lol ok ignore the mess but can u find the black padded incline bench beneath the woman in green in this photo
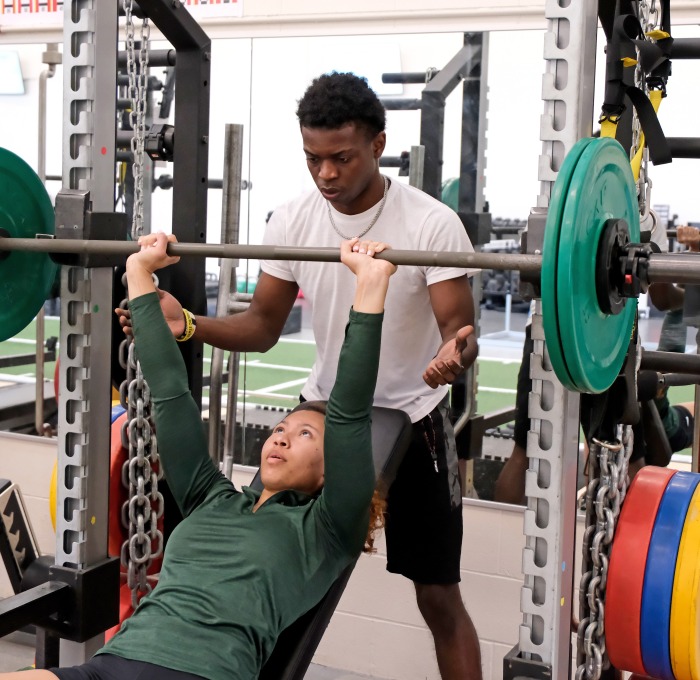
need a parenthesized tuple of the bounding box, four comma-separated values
(250, 406, 412, 680)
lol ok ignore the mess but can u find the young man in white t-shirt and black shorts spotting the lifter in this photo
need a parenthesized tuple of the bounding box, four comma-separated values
(124, 73, 482, 680)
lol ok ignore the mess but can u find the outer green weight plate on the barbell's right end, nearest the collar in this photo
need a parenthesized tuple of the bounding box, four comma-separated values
(557, 138, 639, 394)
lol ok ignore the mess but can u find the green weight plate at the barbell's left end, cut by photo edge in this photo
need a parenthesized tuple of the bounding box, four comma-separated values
(0, 148, 56, 341)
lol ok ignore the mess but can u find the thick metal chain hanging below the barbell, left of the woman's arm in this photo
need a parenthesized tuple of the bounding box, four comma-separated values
(119, 278, 163, 607)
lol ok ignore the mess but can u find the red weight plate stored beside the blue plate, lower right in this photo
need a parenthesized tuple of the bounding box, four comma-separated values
(605, 465, 676, 675)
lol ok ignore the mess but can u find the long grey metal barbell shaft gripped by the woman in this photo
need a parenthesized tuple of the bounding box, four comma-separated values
(0, 238, 542, 273)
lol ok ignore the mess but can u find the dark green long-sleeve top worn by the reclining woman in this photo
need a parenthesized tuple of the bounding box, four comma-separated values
(101, 293, 382, 680)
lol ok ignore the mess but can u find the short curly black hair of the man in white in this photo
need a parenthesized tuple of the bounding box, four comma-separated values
(297, 71, 386, 137)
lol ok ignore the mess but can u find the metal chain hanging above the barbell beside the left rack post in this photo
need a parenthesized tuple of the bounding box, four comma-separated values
(122, 0, 151, 241)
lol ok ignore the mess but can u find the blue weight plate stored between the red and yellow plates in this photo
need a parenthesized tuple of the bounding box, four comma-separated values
(640, 472, 700, 680)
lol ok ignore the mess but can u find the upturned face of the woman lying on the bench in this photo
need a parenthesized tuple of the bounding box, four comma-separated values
(260, 411, 325, 495)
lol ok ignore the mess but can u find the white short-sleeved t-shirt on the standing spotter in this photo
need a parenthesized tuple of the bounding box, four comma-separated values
(261, 181, 474, 422)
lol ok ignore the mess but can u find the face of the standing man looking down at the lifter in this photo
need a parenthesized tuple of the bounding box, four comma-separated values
(301, 123, 386, 215)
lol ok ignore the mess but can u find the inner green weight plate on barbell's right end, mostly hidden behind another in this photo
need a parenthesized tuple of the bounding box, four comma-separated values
(541, 137, 592, 389)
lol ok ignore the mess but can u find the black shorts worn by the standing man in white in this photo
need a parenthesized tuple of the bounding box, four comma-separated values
(386, 400, 462, 585)
